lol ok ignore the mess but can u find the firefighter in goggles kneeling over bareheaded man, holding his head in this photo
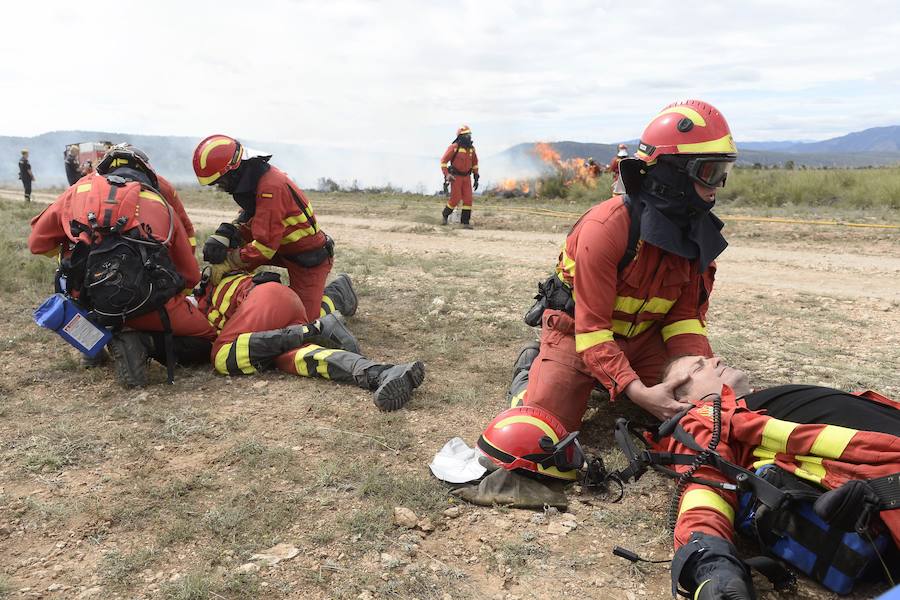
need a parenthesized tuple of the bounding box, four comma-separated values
(516, 100, 737, 431)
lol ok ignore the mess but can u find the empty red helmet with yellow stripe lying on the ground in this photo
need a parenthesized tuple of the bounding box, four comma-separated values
(478, 406, 584, 481)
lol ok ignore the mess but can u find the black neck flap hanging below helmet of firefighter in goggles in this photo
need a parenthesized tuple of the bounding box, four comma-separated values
(640, 158, 728, 273)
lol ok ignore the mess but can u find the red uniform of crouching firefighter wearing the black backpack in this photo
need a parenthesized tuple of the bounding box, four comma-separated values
(28, 174, 215, 339)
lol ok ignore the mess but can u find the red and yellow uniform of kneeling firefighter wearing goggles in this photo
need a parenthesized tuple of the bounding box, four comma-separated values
(512, 196, 715, 431)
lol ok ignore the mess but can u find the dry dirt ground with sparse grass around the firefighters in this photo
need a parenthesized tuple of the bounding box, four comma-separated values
(0, 192, 900, 600)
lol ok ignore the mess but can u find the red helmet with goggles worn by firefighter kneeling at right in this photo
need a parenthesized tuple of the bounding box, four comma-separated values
(635, 100, 737, 187)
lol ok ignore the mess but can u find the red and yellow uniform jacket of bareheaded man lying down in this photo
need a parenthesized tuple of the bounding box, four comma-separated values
(658, 386, 900, 549)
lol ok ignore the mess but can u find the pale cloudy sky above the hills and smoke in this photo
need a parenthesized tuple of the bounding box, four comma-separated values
(0, 0, 900, 155)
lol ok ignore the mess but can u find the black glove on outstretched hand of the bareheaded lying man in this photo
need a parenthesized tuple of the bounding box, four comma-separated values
(672, 533, 756, 600)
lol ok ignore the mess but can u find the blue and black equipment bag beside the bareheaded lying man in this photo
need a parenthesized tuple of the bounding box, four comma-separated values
(735, 465, 893, 595)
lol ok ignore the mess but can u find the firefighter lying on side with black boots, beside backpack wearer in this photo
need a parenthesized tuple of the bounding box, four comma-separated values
(197, 271, 425, 411)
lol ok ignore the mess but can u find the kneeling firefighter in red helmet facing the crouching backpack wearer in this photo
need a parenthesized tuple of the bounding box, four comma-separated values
(193, 135, 334, 315)
